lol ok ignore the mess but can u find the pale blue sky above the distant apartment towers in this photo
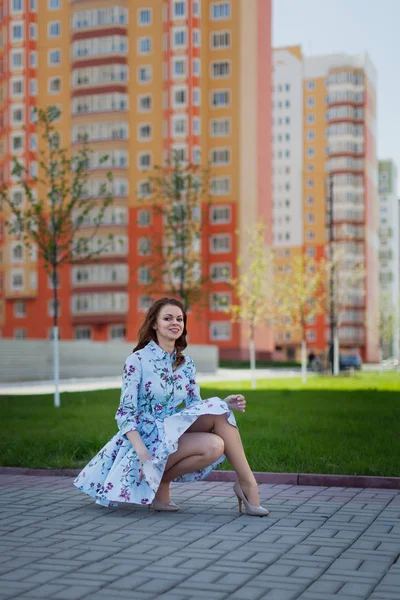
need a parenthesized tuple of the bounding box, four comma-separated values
(272, 0, 400, 188)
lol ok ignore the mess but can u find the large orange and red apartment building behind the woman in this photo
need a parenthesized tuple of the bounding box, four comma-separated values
(0, 0, 272, 355)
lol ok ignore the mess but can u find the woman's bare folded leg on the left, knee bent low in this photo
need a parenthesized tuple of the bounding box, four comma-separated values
(156, 431, 224, 502)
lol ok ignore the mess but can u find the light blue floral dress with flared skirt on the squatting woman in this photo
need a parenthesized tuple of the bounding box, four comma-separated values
(74, 341, 236, 506)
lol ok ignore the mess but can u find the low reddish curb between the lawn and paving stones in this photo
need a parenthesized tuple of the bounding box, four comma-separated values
(0, 467, 400, 490)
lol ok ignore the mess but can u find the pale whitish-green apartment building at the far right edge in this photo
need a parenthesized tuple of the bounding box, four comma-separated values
(379, 160, 400, 358)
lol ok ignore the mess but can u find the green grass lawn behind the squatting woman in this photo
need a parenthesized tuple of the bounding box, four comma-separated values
(0, 373, 400, 476)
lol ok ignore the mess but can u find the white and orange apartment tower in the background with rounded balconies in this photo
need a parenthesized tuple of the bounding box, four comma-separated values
(272, 46, 379, 361)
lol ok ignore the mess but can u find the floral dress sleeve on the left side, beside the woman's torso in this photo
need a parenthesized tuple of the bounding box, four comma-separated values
(115, 354, 142, 435)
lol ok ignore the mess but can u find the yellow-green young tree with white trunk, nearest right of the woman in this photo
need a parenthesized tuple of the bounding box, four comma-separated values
(226, 219, 274, 390)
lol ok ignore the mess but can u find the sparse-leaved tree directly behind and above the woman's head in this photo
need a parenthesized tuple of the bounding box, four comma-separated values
(141, 151, 209, 310)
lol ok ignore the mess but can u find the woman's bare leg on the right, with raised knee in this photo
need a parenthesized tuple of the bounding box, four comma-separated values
(188, 414, 260, 506)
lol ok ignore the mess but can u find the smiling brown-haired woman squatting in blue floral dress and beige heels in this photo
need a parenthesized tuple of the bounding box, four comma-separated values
(74, 298, 269, 516)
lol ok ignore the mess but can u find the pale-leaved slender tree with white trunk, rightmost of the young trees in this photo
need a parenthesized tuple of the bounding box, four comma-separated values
(326, 243, 365, 375)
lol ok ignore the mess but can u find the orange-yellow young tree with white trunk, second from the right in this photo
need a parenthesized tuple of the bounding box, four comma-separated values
(276, 253, 325, 383)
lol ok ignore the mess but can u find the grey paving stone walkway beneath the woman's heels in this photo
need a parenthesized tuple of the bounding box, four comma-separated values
(0, 475, 400, 600)
